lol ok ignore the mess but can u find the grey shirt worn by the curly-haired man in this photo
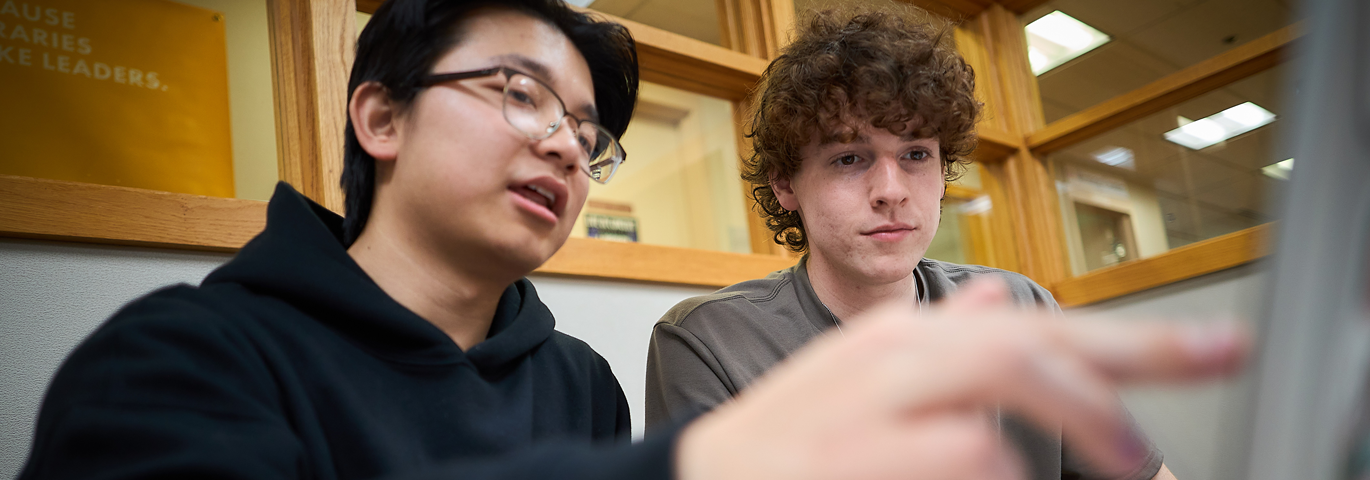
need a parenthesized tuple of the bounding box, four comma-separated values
(647, 256, 1162, 479)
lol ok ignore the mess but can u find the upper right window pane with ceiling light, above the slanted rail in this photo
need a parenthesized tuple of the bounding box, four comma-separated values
(1019, 0, 1296, 123)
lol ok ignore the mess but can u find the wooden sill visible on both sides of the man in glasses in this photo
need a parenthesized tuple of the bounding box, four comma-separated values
(0, 176, 796, 287)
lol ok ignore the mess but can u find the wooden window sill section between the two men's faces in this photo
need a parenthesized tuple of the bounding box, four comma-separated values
(536, 239, 796, 288)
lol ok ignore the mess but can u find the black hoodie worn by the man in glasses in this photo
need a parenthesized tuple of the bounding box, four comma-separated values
(19, 184, 673, 479)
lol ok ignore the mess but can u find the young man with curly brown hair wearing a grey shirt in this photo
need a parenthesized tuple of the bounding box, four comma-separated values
(647, 7, 1170, 479)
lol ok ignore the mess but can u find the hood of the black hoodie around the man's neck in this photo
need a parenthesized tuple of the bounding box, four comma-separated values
(203, 182, 555, 372)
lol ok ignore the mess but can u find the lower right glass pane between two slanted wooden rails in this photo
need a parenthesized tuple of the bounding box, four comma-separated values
(1049, 67, 1296, 274)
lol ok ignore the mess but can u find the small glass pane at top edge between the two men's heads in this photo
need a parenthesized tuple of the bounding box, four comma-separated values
(583, 0, 722, 45)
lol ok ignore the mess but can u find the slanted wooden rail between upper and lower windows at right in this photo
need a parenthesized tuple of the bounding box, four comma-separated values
(1028, 23, 1302, 155)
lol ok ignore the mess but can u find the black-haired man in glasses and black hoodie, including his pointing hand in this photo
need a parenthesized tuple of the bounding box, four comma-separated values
(21, 0, 1244, 480)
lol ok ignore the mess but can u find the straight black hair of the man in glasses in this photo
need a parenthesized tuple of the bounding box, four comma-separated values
(343, 0, 638, 245)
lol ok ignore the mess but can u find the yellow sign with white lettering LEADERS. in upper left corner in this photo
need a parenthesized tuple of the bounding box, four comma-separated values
(0, 0, 233, 197)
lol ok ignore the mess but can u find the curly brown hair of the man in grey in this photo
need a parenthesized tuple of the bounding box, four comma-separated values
(743, 5, 981, 254)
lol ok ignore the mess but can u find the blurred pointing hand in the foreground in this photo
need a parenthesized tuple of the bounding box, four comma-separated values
(675, 278, 1249, 480)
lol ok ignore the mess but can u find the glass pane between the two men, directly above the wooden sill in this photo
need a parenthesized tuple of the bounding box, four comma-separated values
(571, 82, 751, 254)
